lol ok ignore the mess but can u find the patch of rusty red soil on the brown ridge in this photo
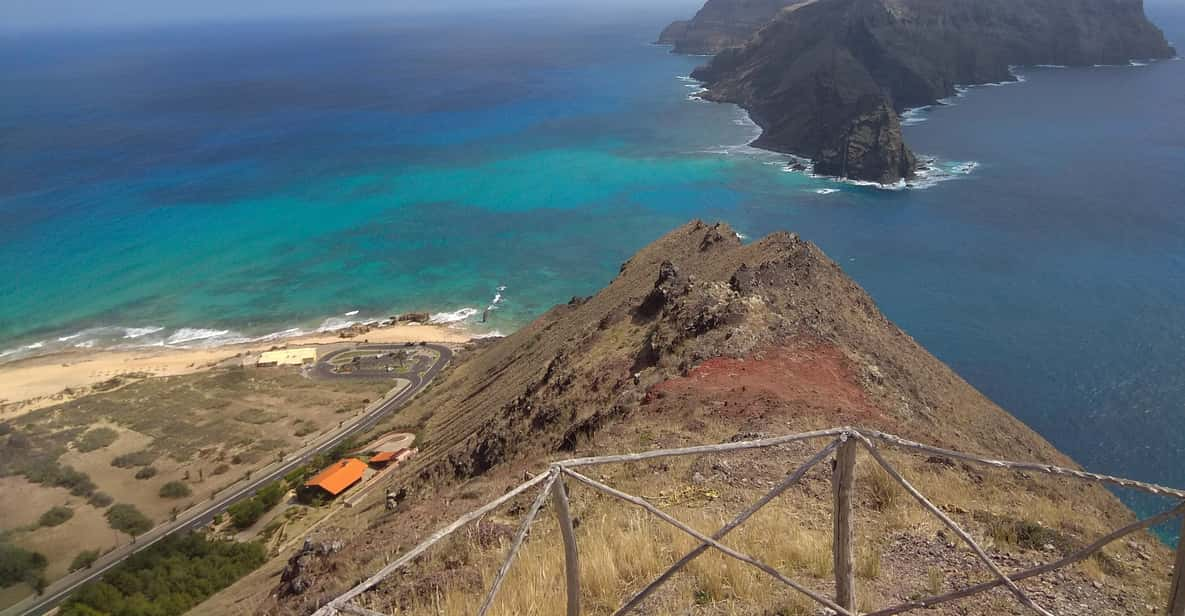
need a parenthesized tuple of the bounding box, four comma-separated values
(647, 342, 882, 423)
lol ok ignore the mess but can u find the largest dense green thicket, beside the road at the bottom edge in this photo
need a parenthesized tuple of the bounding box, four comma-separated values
(60, 533, 267, 616)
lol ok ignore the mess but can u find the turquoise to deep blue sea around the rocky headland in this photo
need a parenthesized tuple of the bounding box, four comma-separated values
(0, 1, 1185, 525)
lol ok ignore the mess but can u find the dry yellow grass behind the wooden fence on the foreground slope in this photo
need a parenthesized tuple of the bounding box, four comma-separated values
(317, 435, 1175, 616)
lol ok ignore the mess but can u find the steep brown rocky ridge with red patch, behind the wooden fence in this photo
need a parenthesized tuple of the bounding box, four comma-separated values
(223, 222, 1170, 615)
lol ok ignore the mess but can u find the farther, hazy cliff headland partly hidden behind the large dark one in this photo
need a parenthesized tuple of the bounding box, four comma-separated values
(658, 0, 803, 54)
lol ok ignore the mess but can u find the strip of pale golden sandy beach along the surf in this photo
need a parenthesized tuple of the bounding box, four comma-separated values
(0, 323, 472, 419)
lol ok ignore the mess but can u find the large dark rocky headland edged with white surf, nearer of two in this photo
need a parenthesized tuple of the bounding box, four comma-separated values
(693, 0, 1174, 184)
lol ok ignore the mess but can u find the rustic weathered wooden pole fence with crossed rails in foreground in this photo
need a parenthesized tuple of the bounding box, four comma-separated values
(314, 428, 1185, 616)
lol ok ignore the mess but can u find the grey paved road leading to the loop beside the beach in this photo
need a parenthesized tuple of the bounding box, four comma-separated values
(0, 345, 453, 616)
